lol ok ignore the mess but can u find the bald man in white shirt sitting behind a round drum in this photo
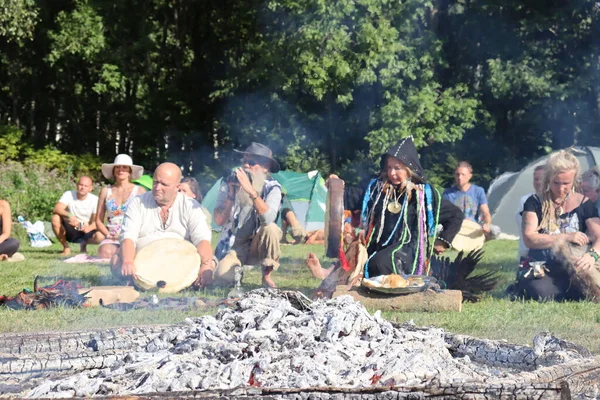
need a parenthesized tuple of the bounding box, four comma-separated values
(111, 163, 215, 286)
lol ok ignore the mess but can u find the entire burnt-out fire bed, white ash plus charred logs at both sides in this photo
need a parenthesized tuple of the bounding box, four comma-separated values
(0, 289, 600, 398)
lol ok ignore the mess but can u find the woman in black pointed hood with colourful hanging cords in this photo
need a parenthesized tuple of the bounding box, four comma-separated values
(307, 137, 463, 292)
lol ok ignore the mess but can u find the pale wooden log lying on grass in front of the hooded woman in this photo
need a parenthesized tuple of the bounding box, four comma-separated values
(333, 286, 462, 312)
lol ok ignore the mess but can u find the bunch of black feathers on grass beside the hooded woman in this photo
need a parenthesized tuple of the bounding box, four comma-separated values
(430, 249, 499, 302)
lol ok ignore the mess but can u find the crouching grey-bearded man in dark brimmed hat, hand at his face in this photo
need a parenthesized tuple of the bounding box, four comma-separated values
(213, 142, 281, 287)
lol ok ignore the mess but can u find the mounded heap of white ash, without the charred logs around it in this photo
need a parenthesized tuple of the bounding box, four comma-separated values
(18, 290, 576, 398)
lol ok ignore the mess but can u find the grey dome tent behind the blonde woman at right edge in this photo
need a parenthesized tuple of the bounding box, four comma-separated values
(487, 147, 600, 236)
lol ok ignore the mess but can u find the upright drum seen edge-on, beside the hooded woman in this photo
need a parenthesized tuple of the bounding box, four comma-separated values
(325, 179, 344, 258)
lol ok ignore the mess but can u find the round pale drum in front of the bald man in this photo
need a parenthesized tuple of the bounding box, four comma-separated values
(133, 238, 200, 293)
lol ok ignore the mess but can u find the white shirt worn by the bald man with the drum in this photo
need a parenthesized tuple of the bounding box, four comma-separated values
(120, 191, 211, 250)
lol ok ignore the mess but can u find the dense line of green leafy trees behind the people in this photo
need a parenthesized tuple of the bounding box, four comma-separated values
(0, 0, 600, 185)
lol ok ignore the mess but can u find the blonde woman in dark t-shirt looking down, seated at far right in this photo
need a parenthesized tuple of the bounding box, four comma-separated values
(515, 150, 600, 301)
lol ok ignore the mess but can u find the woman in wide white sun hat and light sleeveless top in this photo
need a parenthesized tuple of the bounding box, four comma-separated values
(96, 154, 146, 258)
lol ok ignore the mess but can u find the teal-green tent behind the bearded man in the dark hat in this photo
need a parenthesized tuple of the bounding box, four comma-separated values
(202, 171, 327, 231)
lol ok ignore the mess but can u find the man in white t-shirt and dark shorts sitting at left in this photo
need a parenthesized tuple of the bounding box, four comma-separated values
(51, 176, 104, 256)
